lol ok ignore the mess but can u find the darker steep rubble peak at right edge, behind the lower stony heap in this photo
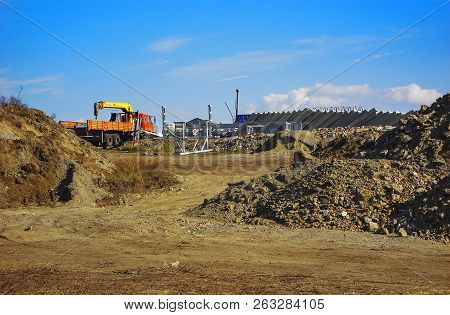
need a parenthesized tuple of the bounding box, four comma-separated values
(375, 94, 450, 164)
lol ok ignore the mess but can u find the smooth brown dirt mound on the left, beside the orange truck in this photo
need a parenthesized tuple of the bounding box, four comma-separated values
(0, 100, 113, 208)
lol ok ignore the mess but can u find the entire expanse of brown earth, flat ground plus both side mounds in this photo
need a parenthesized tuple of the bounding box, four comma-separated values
(0, 95, 450, 294)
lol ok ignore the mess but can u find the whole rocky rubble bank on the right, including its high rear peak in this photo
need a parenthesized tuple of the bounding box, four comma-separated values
(192, 94, 450, 243)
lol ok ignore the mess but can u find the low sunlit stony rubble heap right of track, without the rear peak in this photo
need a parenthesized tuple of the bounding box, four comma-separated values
(190, 159, 448, 241)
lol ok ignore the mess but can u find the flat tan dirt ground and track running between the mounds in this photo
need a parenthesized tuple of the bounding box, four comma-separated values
(0, 152, 450, 294)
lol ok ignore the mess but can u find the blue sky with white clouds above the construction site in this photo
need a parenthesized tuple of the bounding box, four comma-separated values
(0, 0, 450, 121)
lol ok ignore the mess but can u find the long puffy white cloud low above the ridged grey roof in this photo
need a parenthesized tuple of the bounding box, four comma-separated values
(258, 83, 441, 111)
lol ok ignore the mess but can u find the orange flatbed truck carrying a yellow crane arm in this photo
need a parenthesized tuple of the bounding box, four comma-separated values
(59, 101, 158, 149)
